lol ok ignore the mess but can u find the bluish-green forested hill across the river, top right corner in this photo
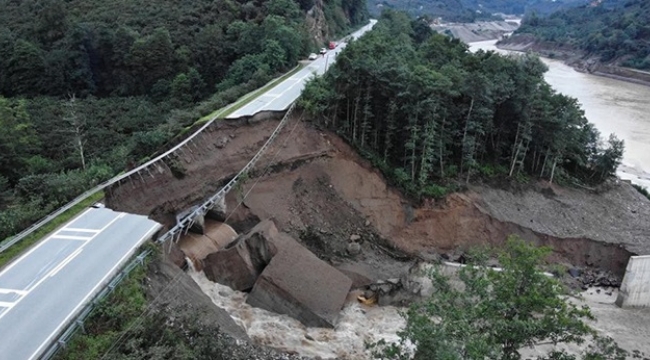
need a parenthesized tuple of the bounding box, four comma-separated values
(515, 0, 650, 70)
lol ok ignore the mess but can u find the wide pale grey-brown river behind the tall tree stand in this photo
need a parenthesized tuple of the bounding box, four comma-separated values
(469, 40, 650, 189)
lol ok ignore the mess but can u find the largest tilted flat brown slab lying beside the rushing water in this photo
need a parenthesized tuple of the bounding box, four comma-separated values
(246, 228, 352, 328)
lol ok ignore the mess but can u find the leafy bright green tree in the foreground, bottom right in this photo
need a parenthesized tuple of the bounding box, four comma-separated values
(375, 236, 625, 360)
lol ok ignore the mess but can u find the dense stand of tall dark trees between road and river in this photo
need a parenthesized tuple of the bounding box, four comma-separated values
(300, 11, 623, 196)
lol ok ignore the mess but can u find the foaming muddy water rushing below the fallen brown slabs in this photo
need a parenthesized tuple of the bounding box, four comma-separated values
(189, 270, 405, 360)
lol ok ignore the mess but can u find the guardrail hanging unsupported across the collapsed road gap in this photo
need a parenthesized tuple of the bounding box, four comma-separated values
(158, 102, 296, 243)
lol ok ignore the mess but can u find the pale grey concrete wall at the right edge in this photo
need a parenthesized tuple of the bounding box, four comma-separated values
(616, 255, 650, 307)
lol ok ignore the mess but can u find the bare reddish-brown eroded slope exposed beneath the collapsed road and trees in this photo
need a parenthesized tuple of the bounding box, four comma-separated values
(108, 112, 650, 275)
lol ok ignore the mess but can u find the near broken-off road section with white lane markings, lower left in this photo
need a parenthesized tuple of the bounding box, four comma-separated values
(0, 208, 160, 360)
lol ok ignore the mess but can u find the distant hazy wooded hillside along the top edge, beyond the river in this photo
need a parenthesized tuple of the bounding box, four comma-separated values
(368, 0, 589, 22)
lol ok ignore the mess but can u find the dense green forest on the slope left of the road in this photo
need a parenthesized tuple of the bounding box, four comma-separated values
(0, 0, 368, 240)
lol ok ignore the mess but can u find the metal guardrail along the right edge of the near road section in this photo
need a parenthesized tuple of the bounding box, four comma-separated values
(40, 250, 151, 360)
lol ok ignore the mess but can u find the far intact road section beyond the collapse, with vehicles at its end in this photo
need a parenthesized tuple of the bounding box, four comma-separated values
(227, 20, 377, 119)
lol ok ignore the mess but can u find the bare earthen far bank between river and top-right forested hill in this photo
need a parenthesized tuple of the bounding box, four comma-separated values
(496, 35, 650, 86)
